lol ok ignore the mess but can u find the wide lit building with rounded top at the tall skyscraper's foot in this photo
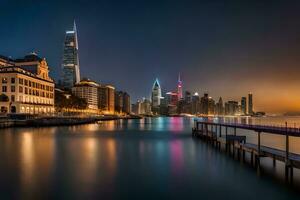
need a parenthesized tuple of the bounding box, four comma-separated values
(72, 79, 99, 110)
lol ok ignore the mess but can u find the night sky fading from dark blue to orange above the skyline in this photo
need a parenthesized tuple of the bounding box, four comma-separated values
(0, 0, 300, 113)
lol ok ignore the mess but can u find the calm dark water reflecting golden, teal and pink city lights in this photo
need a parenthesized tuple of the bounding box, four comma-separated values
(0, 118, 300, 200)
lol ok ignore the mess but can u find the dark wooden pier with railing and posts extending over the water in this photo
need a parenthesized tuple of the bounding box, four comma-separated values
(192, 121, 300, 182)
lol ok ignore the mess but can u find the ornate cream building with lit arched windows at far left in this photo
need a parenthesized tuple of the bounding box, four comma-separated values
(0, 53, 54, 114)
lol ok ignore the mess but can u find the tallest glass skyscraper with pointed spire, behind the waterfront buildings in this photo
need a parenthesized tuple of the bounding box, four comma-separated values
(62, 21, 80, 89)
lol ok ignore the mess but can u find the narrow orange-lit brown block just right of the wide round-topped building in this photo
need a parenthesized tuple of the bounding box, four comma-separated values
(98, 85, 115, 114)
